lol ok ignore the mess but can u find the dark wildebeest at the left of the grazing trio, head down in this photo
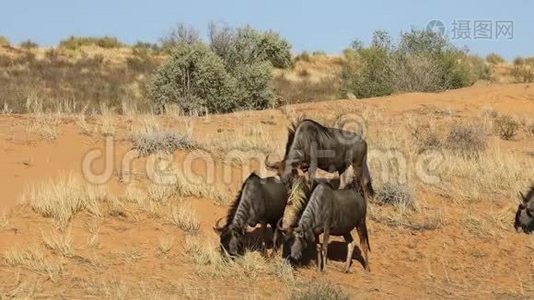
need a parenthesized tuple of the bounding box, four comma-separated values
(213, 173, 288, 257)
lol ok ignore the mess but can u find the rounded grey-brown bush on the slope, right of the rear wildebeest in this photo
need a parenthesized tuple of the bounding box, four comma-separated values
(445, 123, 487, 157)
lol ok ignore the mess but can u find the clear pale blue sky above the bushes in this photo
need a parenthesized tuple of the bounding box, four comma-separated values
(0, 0, 534, 59)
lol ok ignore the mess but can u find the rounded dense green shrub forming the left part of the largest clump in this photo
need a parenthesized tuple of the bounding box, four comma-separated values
(149, 43, 241, 113)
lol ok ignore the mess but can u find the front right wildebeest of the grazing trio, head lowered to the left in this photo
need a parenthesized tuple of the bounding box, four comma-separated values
(277, 179, 371, 272)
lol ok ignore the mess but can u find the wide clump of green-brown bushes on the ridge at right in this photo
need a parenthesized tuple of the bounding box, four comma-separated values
(341, 30, 491, 98)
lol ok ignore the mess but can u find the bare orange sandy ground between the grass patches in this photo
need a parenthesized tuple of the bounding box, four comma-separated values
(0, 85, 534, 299)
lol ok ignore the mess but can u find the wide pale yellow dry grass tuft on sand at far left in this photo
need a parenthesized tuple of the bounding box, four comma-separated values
(21, 174, 108, 228)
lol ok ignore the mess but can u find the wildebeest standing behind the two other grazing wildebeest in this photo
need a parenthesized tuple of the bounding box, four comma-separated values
(265, 119, 374, 196)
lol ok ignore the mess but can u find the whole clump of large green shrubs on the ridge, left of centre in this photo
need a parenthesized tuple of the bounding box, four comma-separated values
(149, 24, 280, 113)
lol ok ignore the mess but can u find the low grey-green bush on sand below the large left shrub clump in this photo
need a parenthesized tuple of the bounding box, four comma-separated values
(132, 131, 194, 156)
